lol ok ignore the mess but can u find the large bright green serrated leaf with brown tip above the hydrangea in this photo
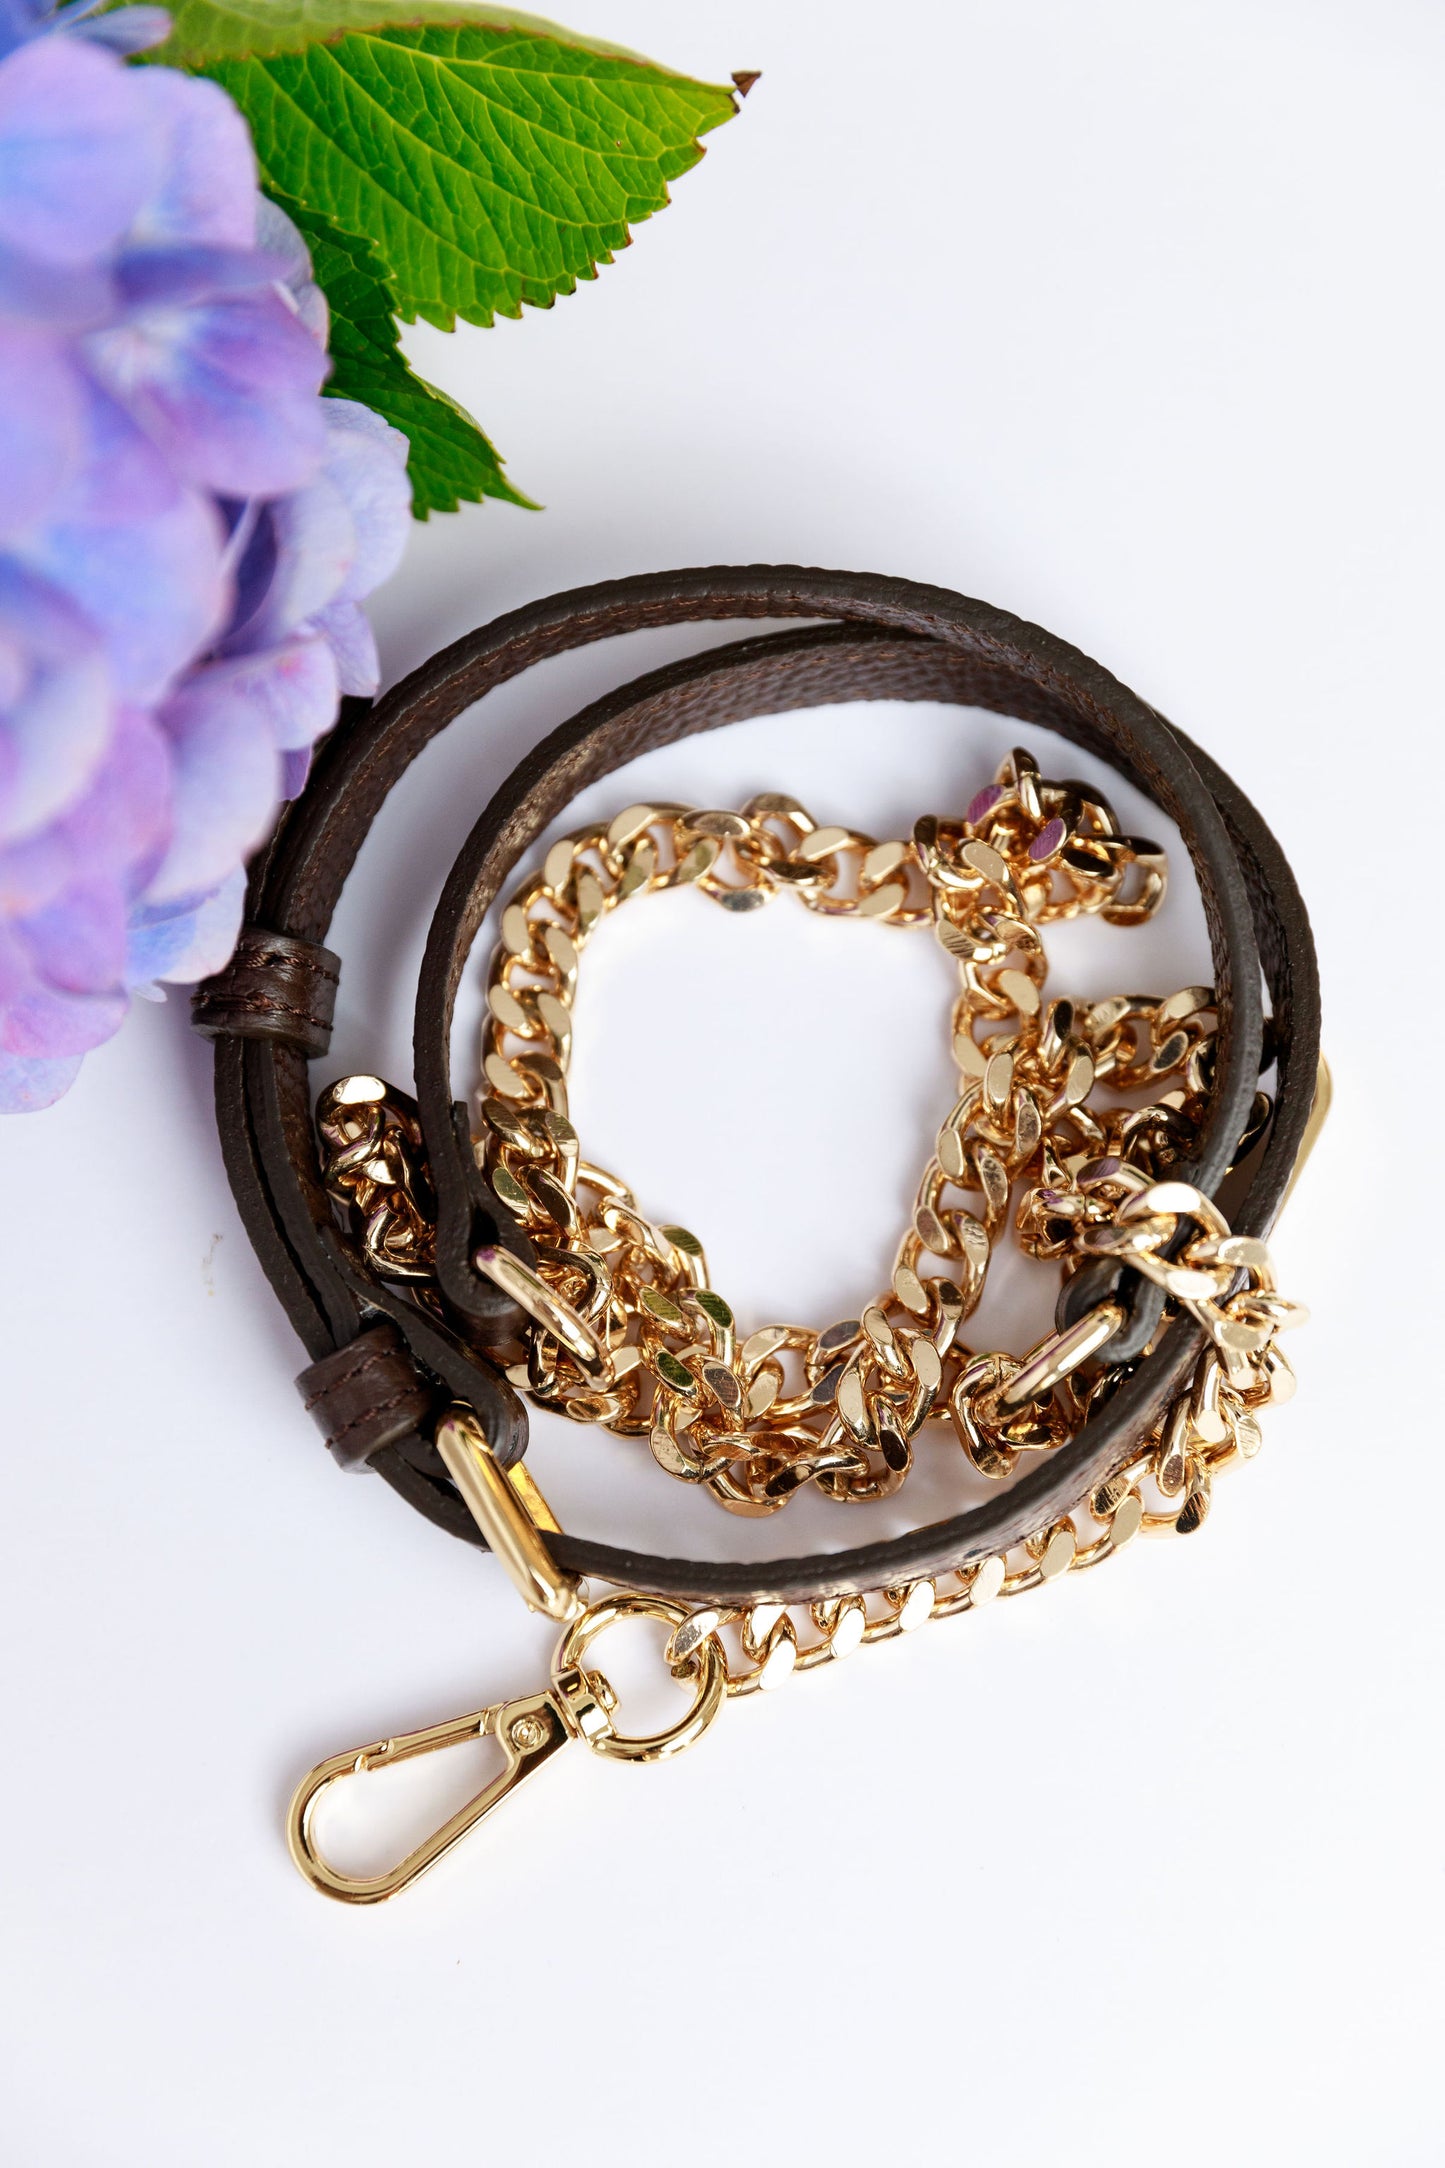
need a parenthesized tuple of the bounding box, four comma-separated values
(156, 0, 737, 330)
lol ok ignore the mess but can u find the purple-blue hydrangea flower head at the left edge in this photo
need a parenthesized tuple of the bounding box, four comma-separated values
(0, 25, 409, 1110)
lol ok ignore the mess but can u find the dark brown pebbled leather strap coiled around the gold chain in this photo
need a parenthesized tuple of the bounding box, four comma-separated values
(203, 566, 1319, 1602)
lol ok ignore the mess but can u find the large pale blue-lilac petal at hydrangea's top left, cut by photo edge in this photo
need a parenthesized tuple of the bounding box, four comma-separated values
(0, 39, 165, 264)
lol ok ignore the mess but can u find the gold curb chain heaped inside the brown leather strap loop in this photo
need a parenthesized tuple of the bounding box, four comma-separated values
(454, 750, 1265, 1515)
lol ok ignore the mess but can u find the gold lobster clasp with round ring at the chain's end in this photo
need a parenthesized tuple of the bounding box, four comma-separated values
(286, 1593, 728, 1904)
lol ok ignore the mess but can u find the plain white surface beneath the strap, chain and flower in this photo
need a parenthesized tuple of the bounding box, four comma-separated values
(0, 0, 1445, 2168)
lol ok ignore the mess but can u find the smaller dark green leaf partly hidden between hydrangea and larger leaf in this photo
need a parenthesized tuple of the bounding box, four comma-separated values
(279, 197, 537, 520)
